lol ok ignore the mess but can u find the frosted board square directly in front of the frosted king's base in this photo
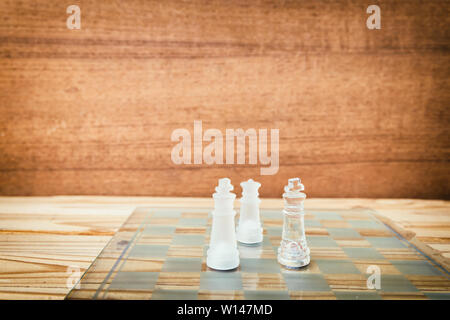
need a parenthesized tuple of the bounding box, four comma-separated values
(200, 271, 242, 290)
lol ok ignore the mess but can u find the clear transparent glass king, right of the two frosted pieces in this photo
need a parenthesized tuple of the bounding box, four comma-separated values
(278, 178, 310, 268)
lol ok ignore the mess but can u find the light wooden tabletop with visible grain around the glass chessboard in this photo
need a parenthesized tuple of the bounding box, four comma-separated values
(0, 196, 450, 299)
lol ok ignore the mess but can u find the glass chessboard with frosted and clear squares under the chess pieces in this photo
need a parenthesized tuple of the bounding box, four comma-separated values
(66, 208, 450, 300)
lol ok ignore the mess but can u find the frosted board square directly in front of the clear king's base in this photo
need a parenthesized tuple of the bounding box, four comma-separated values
(283, 273, 331, 291)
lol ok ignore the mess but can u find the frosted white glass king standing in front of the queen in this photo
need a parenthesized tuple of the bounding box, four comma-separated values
(206, 178, 239, 270)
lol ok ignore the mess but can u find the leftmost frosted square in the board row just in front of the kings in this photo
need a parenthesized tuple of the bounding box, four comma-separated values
(109, 272, 159, 290)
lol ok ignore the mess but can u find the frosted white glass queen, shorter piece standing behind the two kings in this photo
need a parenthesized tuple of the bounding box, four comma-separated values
(236, 179, 263, 244)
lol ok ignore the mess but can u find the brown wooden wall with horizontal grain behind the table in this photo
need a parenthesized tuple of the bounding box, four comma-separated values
(0, 0, 450, 198)
